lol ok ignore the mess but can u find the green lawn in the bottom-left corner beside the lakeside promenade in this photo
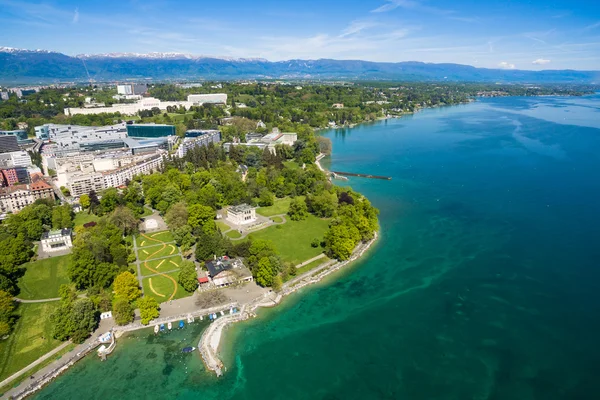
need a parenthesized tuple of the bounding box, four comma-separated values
(0, 301, 61, 380)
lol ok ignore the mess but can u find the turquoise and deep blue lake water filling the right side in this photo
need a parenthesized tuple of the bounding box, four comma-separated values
(37, 96, 600, 400)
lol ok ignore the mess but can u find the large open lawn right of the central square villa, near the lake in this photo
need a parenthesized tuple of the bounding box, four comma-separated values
(248, 215, 329, 264)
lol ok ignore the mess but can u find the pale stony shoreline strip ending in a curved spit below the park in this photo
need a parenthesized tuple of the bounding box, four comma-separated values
(198, 232, 379, 377)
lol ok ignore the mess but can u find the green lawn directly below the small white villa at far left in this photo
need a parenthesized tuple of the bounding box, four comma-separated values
(18, 254, 71, 300)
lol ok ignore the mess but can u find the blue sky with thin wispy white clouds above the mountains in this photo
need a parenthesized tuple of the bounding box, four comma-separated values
(0, 0, 600, 70)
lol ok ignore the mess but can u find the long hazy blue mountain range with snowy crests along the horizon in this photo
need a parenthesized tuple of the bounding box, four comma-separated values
(0, 47, 600, 84)
